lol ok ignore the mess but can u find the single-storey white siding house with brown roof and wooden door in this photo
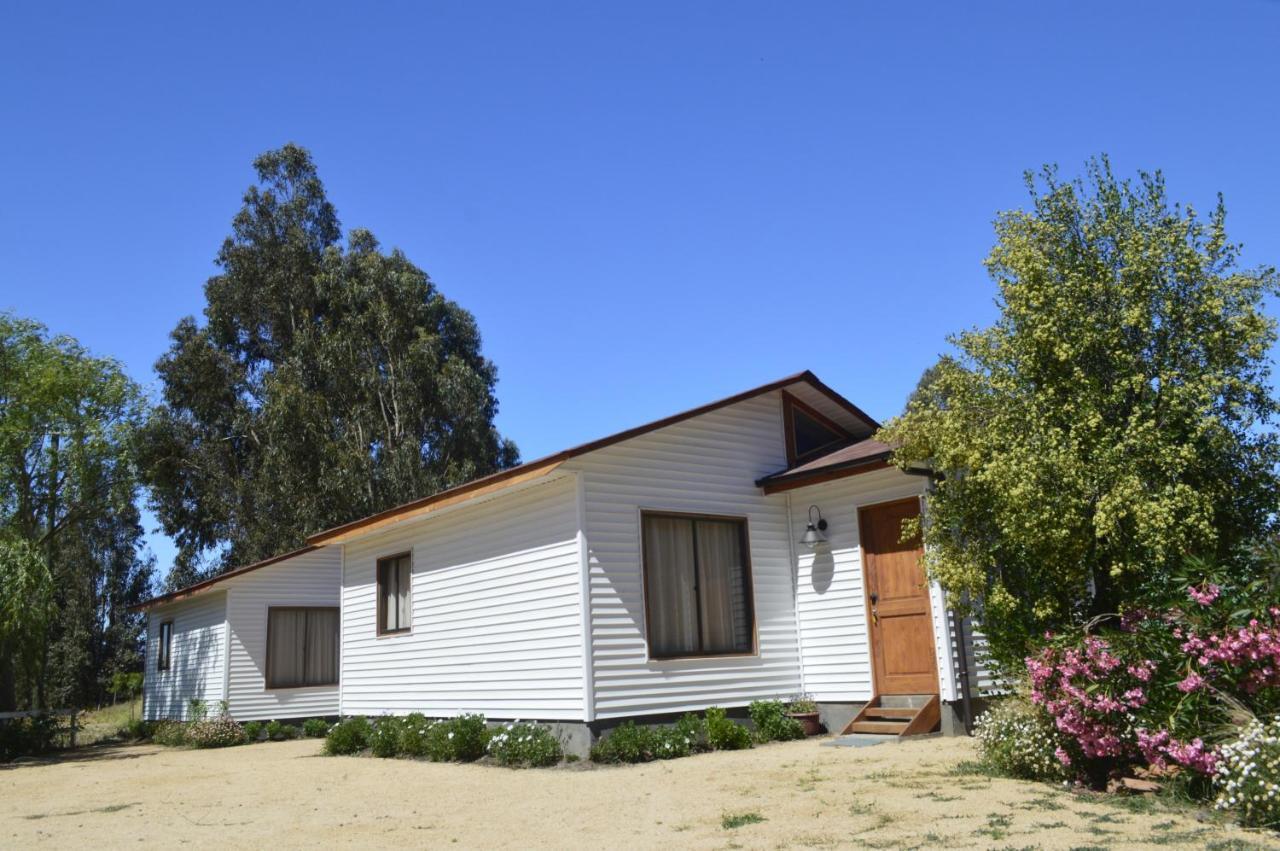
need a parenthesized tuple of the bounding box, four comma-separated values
(145, 372, 986, 733)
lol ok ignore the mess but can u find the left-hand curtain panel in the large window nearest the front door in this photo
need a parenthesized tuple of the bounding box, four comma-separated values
(644, 516, 699, 656)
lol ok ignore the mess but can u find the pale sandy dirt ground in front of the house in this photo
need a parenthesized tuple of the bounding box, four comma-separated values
(0, 738, 1277, 848)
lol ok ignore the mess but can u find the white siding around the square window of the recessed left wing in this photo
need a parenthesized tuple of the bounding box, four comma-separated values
(227, 546, 342, 720)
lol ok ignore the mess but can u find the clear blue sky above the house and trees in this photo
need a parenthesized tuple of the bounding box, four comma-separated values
(0, 0, 1280, 563)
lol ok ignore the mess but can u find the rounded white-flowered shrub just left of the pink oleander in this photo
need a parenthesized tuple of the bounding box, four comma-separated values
(973, 697, 1076, 781)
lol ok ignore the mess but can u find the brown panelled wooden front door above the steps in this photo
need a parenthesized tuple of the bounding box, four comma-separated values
(858, 498, 938, 695)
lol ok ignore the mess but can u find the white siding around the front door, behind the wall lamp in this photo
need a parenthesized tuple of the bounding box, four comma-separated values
(788, 470, 950, 703)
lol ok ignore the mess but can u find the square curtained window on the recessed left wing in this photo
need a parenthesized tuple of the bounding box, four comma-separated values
(266, 607, 338, 688)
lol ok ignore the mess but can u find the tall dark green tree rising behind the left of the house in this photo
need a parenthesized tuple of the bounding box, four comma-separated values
(140, 145, 517, 585)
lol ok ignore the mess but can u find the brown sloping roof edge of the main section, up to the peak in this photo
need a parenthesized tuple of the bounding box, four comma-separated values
(307, 370, 879, 546)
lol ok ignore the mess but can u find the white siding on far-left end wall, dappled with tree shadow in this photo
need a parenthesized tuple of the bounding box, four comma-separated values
(142, 593, 227, 720)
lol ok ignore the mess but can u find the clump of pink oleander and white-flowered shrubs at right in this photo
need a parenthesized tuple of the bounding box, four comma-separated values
(979, 550, 1280, 824)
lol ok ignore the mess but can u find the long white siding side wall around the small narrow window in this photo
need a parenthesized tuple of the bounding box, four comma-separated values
(342, 476, 585, 720)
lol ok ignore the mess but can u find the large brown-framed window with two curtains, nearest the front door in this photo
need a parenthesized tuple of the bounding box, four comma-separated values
(641, 512, 755, 659)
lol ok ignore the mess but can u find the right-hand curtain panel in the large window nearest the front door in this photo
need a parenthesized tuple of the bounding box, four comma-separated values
(695, 520, 751, 653)
